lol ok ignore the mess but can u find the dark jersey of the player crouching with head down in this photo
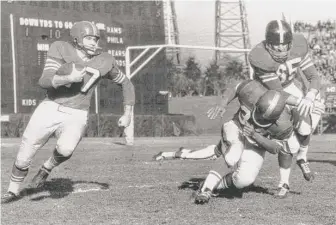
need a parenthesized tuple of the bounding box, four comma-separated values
(233, 80, 293, 142)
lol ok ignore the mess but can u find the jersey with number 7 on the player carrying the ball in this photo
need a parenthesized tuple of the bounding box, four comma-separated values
(41, 41, 124, 110)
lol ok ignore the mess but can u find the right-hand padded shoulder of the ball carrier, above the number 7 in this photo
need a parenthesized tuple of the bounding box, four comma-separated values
(86, 52, 115, 76)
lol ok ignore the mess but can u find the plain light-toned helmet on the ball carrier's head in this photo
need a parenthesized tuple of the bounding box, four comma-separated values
(70, 21, 101, 56)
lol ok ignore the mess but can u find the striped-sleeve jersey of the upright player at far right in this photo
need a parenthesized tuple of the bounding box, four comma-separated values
(249, 34, 320, 90)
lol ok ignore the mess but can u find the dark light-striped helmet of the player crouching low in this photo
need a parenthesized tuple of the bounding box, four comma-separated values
(252, 90, 286, 127)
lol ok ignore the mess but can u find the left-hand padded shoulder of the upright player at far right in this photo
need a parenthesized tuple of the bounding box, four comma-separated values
(249, 42, 278, 73)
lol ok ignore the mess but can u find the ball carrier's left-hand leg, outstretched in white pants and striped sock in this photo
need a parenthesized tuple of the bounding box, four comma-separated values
(1, 101, 58, 203)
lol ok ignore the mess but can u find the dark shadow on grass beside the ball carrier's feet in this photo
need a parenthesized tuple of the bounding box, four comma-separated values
(20, 178, 109, 201)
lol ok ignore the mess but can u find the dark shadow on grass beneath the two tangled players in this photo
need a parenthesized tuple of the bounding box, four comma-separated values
(178, 178, 301, 199)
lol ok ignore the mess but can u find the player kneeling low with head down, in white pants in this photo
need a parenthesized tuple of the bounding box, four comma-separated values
(195, 80, 301, 204)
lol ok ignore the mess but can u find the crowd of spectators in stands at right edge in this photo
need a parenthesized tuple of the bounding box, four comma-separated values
(293, 21, 336, 83)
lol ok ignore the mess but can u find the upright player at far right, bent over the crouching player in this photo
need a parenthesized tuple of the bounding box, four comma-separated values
(249, 20, 324, 186)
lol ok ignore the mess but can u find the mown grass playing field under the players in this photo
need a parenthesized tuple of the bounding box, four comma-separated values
(1, 135, 336, 225)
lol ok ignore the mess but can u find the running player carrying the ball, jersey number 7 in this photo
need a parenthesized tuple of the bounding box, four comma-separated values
(1, 21, 135, 203)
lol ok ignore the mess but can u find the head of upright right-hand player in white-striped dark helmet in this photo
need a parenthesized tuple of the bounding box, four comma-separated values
(265, 20, 293, 63)
